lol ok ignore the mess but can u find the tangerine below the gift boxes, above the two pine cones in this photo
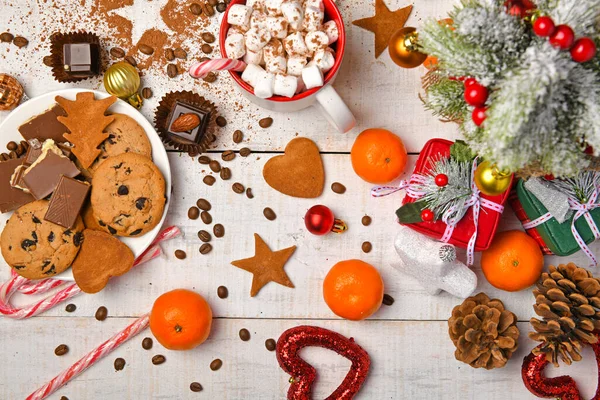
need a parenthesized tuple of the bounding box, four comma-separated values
(481, 230, 544, 292)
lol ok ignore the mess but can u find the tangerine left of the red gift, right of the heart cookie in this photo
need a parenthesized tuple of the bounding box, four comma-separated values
(350, 129, 407, 184)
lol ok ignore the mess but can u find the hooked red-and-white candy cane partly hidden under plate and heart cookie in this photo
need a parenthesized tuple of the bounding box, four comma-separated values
(0, 226, 181, 319)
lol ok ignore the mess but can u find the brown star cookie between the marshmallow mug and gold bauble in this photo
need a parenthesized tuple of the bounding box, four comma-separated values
(352, 0, 412, 58)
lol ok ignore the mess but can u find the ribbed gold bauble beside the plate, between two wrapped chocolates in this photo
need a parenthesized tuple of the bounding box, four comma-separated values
(104, 61, 142, 108)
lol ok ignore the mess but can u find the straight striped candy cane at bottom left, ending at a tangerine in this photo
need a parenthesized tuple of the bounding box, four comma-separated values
(27, 314, 150, 400)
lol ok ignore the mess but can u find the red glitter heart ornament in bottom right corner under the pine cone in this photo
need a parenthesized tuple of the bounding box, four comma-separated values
(521, 332, 600, 400)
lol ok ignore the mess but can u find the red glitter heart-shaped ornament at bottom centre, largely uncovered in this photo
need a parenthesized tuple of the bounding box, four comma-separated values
(277, 325, 371, 400)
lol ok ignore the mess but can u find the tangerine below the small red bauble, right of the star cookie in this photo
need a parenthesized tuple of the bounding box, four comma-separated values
(323, 260, 383, 321)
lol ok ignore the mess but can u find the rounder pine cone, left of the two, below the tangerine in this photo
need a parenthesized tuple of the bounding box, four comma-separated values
(448, 293, 519, 369)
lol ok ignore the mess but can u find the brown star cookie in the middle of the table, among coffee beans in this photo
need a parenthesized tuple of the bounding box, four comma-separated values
(231, 233, 296, 297)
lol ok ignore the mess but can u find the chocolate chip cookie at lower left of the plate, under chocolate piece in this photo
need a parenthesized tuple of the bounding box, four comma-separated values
(0, 200, 84, 279)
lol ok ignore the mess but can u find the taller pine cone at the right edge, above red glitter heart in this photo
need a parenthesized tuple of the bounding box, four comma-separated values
(529, 263, 600, 366)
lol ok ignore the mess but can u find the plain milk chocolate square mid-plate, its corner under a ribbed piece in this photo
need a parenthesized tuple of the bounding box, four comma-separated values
(23, 150, 80, 200)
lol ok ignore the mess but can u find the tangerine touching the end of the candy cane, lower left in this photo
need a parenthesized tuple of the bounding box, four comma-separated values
(150, 289, 212, 350)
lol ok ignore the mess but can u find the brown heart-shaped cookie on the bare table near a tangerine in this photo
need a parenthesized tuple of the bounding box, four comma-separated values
(263, 138, 325, 199)
